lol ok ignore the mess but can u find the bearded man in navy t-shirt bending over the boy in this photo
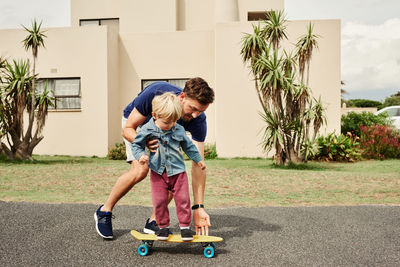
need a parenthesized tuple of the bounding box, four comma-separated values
(94, 78, 214, 238)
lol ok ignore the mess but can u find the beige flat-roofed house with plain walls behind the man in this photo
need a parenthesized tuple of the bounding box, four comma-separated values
(0, 0, 341, 157)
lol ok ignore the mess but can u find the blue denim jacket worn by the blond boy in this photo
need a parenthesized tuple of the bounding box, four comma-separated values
(132, 118, 202, 177)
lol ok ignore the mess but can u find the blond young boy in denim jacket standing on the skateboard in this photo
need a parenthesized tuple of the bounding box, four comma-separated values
(132, 92, 206, 241)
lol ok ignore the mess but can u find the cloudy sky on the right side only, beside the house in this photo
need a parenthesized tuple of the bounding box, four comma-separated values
(285, 0, 400, 101)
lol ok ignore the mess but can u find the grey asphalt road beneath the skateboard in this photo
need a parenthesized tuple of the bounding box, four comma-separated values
(0, 202, 400, 266)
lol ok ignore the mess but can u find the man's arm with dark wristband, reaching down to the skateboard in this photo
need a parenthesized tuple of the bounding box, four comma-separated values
(192, 140, 211, 235)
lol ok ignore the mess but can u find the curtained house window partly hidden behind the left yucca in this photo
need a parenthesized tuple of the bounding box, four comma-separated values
(37, 78, 81, 110)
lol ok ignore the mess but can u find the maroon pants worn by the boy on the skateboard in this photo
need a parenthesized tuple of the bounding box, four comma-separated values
(150, 171, 192, 228)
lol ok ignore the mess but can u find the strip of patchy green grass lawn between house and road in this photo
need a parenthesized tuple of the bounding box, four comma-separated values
(0, 156, 400, 208)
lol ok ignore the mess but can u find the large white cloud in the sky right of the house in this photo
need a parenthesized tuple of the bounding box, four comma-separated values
(342, 18, 400, 95)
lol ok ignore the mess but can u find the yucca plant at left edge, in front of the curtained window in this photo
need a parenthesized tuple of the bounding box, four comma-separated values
(0, 21, 54, 160)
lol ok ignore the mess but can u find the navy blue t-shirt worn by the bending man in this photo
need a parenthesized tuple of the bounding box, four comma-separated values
(124, 82, 207, 142)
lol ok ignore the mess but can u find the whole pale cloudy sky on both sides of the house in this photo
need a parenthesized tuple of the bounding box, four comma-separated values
(0, 0, 400, 101)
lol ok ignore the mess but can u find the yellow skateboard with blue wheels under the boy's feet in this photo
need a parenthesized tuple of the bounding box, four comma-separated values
(131, 230, 223, 258)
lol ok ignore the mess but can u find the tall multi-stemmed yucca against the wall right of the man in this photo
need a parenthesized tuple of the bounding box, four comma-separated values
(241, 11, 325, 164)
